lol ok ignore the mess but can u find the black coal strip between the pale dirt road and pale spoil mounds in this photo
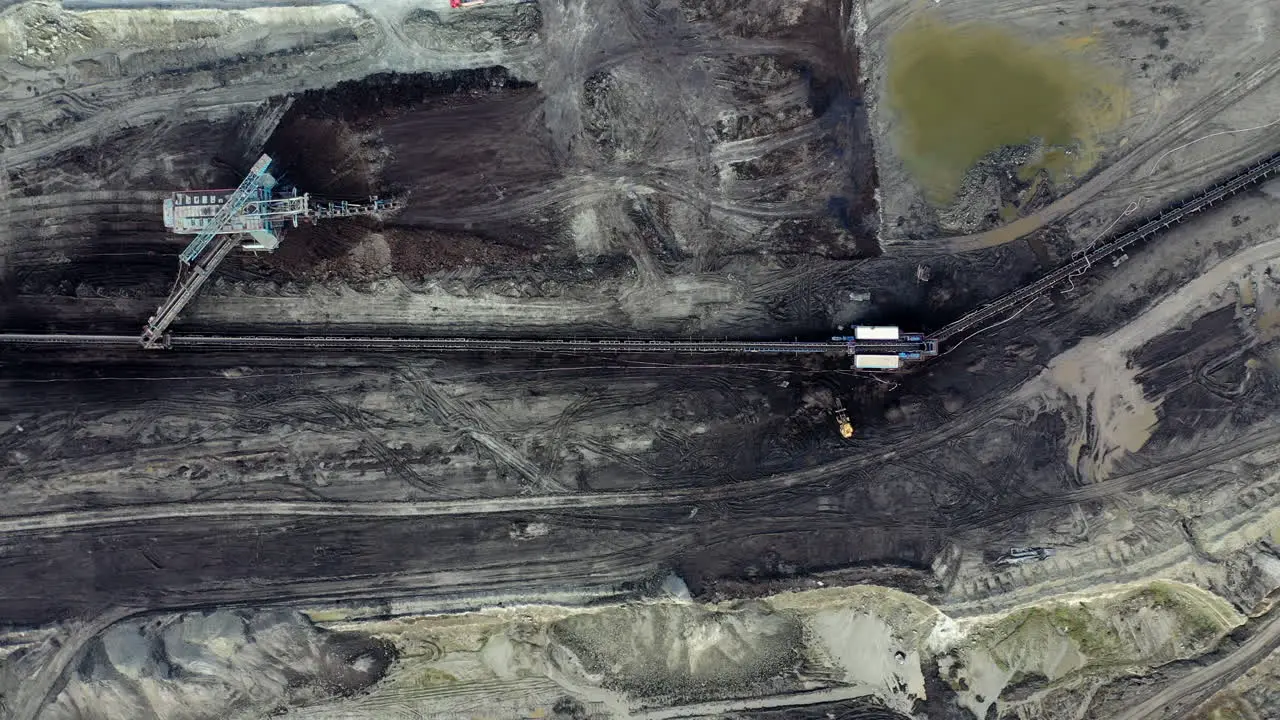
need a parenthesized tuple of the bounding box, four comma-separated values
(0, 484, 947, 626)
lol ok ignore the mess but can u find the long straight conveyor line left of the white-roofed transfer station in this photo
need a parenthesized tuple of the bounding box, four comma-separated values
(0, 333, 924, 355)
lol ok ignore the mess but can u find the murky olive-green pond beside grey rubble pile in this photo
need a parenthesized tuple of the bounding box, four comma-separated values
(887, 17, 1126, 204)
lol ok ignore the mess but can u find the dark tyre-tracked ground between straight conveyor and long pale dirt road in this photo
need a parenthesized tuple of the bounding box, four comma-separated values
(4, 350, 879, 502)
